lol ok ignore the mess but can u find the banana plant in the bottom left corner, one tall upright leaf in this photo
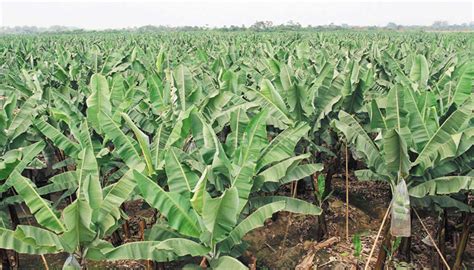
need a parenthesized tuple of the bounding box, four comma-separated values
(0, 122, 150, 265)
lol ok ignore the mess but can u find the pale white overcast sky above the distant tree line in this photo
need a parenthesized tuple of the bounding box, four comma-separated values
(0, 0, 474, 29)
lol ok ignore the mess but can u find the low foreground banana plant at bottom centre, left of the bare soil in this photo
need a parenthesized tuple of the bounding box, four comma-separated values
(98, 167, 320, 269)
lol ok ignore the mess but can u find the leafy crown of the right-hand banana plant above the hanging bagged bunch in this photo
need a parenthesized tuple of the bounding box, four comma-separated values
(333, 85, 473, 226)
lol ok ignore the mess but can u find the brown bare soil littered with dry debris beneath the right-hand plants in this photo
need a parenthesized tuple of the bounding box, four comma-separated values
(246, 178, 474, 270)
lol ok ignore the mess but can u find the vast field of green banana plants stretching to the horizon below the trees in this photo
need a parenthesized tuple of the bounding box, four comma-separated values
(0, 31, 474, 269)
